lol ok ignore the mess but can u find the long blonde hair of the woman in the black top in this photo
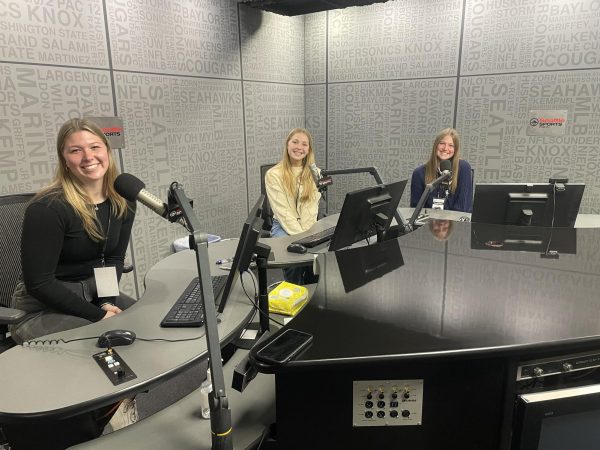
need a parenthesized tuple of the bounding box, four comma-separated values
(33, 119, 128, 241)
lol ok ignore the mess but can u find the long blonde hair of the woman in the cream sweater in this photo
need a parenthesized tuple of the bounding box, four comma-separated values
(279, 128, 317, 202)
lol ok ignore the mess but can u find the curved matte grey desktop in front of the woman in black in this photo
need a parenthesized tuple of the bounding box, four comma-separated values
(0, 240, 253, 423)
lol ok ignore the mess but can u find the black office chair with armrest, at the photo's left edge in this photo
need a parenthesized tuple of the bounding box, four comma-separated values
(0, 193, 34, 351)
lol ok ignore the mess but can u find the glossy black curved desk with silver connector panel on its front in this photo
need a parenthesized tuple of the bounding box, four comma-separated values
(252, 217, 600, 450)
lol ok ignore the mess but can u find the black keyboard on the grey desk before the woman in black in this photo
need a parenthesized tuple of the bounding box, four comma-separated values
(160, 275, 227, 327)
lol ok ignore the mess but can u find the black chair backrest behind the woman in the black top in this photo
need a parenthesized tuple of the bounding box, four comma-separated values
(0, 193, 34, 306)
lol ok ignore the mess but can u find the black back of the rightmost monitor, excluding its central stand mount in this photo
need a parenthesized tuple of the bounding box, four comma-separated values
(471, 183, 585, 228)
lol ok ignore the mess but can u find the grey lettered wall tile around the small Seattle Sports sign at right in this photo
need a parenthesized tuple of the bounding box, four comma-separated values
(457, 70, 600, 213)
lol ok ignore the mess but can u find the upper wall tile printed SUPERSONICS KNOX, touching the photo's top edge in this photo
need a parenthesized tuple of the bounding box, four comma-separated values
(328, 0, 462, 82)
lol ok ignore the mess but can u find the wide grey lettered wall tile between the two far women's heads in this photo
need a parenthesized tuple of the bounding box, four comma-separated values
(327, 78, 456, 212)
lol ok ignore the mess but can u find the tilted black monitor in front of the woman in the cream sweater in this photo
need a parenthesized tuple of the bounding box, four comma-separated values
(329, 180, 408, 251)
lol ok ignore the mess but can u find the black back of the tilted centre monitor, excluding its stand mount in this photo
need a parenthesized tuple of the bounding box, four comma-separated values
(329, 180, 408, 251)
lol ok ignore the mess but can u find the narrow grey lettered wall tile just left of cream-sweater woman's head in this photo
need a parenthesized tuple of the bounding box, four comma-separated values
(244, 82, 305, 200)
